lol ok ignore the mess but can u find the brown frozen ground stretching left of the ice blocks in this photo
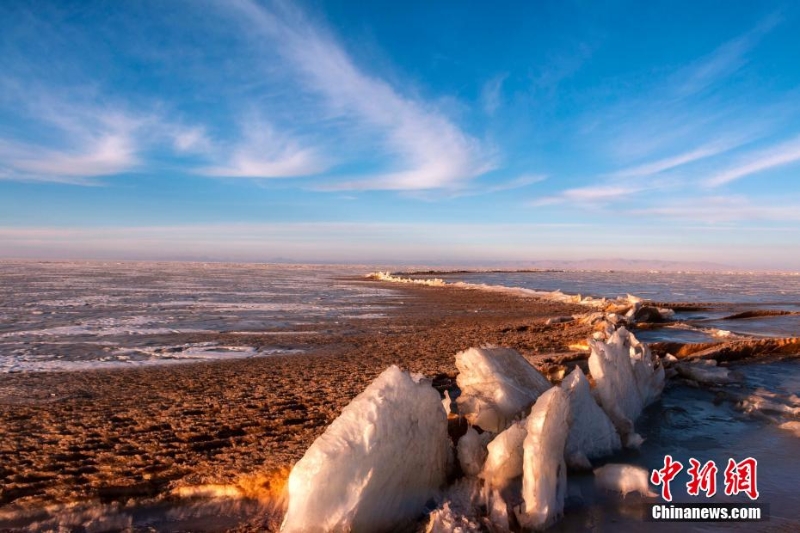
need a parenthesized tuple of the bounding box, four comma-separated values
(0, 281, 590, 515)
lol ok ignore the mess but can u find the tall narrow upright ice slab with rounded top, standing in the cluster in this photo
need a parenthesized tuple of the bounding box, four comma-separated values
(517, 387, 570, 530)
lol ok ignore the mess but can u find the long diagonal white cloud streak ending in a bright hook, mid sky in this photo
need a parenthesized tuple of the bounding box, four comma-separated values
(225, 1, 496, 190)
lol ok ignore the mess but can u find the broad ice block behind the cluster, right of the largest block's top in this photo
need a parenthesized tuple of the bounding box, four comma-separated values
(456, 348, 551, 433)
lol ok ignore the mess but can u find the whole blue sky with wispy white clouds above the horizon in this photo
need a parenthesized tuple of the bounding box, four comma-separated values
(0, 0, 800, 269)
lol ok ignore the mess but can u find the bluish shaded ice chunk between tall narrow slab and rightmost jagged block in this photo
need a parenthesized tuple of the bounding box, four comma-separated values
(561, 367, 622, 468)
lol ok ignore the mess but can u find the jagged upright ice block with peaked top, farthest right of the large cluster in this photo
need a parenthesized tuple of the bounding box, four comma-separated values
(589, 328, 665, 446)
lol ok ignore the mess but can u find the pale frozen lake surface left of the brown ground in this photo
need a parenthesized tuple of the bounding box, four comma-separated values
(0, 262, 392, 372)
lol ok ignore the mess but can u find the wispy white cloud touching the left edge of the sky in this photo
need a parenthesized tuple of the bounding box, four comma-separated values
(0, 79, 216, 185)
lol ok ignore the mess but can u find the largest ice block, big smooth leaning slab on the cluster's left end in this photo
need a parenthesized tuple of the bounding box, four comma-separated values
(281, 366, 449, 532)
